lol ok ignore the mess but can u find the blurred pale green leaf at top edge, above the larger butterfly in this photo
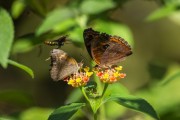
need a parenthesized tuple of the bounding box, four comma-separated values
(80, 0, 116, 14)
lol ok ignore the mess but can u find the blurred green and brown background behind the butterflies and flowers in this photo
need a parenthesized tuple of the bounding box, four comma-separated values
(0, 0, 180, 120)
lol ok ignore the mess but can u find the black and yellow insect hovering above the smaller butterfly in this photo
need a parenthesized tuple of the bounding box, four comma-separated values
(44, 35, 67, 48)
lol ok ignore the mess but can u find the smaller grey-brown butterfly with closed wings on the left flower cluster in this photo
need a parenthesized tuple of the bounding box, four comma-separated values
(50, 49, 82, 81)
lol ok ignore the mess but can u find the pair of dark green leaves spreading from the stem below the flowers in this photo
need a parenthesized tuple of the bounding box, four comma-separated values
(48, 83, 159, 120)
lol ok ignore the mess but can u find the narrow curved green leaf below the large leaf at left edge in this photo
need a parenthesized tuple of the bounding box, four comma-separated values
(8, 60, 34, 78)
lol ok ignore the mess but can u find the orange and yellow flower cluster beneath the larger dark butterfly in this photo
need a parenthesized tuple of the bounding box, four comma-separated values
(94, 66, 126, 83)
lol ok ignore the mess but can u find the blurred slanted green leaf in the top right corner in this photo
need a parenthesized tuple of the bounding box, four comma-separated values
(145, 4, 176, 22)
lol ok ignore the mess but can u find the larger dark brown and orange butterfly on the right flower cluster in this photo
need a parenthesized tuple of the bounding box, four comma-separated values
(83, 28, 132, 68)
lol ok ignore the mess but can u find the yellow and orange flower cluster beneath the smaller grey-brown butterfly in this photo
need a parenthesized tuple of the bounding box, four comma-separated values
(65, 67, 93, 87)
